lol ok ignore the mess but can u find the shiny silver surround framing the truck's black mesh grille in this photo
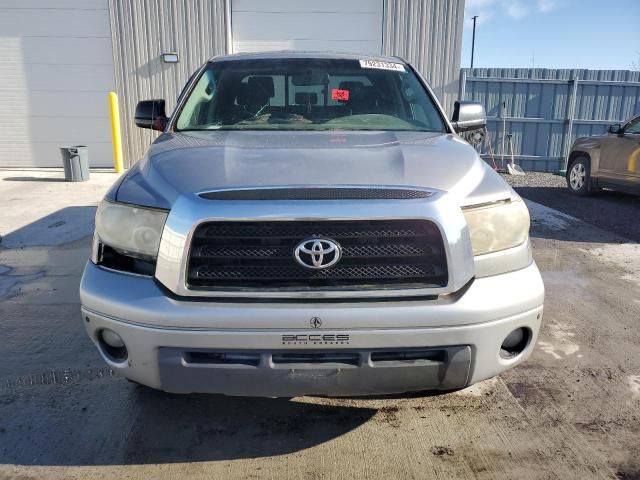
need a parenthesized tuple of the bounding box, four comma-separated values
(155, 187, 474, 301)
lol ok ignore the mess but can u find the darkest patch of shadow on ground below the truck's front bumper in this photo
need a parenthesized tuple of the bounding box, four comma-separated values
(125, 388, 377, 464)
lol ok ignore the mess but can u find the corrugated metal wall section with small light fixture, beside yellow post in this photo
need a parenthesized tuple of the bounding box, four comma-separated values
(105, 0, 227, 165)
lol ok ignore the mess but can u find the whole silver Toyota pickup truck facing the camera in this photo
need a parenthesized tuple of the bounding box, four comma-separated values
(80, 52, 544, 397)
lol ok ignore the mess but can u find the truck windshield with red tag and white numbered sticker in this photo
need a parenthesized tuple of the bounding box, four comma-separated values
(176, 58, 446, 132)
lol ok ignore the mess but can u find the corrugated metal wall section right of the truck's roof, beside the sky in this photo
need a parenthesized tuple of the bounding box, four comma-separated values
(382, 0, 464, 113)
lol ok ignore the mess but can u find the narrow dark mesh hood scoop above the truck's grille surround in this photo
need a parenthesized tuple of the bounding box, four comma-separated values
(200, 185, 434, 200)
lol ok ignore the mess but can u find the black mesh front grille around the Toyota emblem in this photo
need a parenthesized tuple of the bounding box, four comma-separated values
(187, 220, 447, 290)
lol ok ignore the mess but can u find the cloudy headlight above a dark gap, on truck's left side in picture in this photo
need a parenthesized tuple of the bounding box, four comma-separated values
(93, 201, 167, 261)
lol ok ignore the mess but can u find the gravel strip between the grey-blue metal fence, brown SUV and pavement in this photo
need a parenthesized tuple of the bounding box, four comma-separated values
(502, 172, 640, 242)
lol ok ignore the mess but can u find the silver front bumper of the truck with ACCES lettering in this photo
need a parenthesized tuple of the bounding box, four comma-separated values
(80, 262, 544, 396)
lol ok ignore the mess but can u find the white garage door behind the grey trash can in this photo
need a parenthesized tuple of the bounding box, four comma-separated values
(0, 0, 115, 167)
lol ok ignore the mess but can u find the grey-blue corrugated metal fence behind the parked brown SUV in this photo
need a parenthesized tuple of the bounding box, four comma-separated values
(459, 68, 640, 171)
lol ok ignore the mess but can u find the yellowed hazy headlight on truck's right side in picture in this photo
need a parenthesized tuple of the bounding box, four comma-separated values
(463, 198, 530, 255)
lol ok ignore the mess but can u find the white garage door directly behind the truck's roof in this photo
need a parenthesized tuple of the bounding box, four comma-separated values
(231, 0, 383, 54)
